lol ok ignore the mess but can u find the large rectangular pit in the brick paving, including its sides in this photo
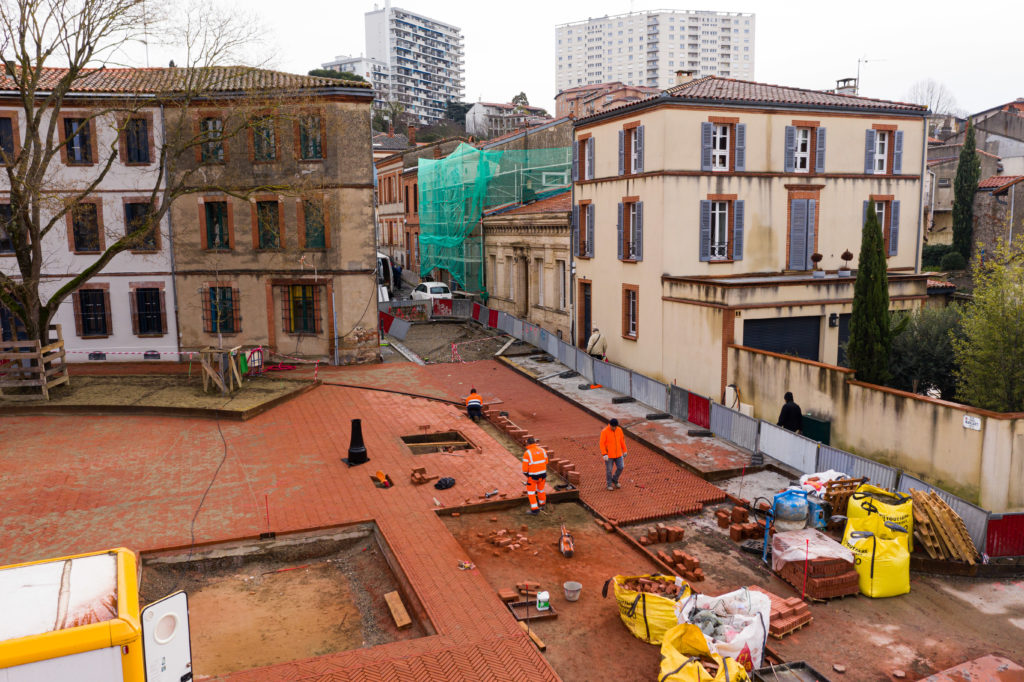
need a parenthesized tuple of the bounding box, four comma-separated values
(140, 522, 435, 677)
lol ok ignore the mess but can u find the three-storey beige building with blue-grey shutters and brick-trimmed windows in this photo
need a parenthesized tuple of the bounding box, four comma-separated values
(572, 77, 927, 399)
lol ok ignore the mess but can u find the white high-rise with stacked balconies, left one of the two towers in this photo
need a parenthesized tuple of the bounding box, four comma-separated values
(324, 0, 465, 124)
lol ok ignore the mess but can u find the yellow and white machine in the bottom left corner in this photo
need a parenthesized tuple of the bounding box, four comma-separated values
(0, 548, 193, 682)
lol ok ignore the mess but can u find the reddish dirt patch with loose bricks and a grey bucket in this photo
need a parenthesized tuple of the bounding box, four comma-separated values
(444, 503, 659, 680)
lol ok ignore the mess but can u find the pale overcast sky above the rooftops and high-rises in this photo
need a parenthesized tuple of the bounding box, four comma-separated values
(153, 0, 1024, 112)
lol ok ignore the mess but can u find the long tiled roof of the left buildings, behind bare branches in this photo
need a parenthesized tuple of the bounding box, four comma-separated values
(0, 67, 373, 94)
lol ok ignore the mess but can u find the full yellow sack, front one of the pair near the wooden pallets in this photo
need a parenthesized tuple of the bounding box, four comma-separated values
(843, 514, 910, 597)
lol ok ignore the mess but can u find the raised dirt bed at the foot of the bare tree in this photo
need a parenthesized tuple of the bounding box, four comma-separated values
(0, 367, 308, 412)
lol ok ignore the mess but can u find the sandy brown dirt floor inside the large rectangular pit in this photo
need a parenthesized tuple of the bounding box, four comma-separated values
(141, 536, 426, 679)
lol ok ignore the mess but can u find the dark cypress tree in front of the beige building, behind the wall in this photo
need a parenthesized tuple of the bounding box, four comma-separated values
(847, 202, 892, 384)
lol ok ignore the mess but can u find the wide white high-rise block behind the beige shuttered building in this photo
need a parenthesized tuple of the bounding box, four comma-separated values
(555, 9, 755, 92)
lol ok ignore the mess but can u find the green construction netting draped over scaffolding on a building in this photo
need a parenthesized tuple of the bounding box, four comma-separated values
(418, 143, 571, 293)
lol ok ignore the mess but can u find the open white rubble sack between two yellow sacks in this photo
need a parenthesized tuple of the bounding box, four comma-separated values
(676, 588, 771, 671)
